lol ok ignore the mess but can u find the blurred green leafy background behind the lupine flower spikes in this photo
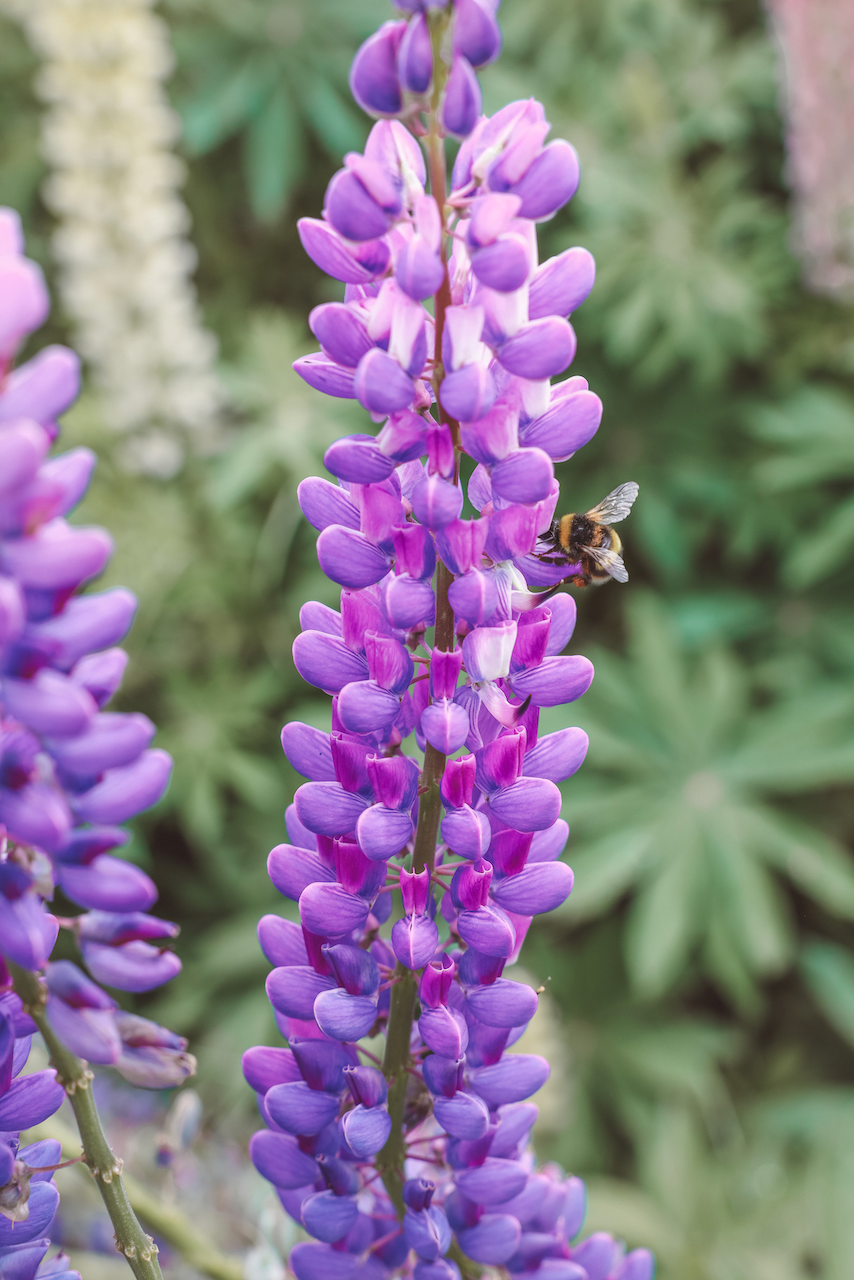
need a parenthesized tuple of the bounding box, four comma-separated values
(0, 0, 854, 1280)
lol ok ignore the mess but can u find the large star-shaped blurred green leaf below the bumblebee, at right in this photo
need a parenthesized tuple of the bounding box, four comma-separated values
(558, 598, 854, 1012)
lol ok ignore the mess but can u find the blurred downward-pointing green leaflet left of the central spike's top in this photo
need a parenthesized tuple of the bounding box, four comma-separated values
(245, 84, 306, 223)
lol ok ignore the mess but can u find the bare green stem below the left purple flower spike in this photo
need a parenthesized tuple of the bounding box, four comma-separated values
(8, 961, 163, 1280)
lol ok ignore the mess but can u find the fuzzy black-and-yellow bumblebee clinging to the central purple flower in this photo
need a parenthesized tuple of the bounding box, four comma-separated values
(534, 480, 638, 594)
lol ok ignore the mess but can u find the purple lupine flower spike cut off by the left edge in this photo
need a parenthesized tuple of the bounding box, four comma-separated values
(0, 209, 193, 1280)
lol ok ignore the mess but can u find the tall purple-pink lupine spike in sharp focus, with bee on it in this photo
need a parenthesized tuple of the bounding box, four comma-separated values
(243, 0, 654, 1280)
